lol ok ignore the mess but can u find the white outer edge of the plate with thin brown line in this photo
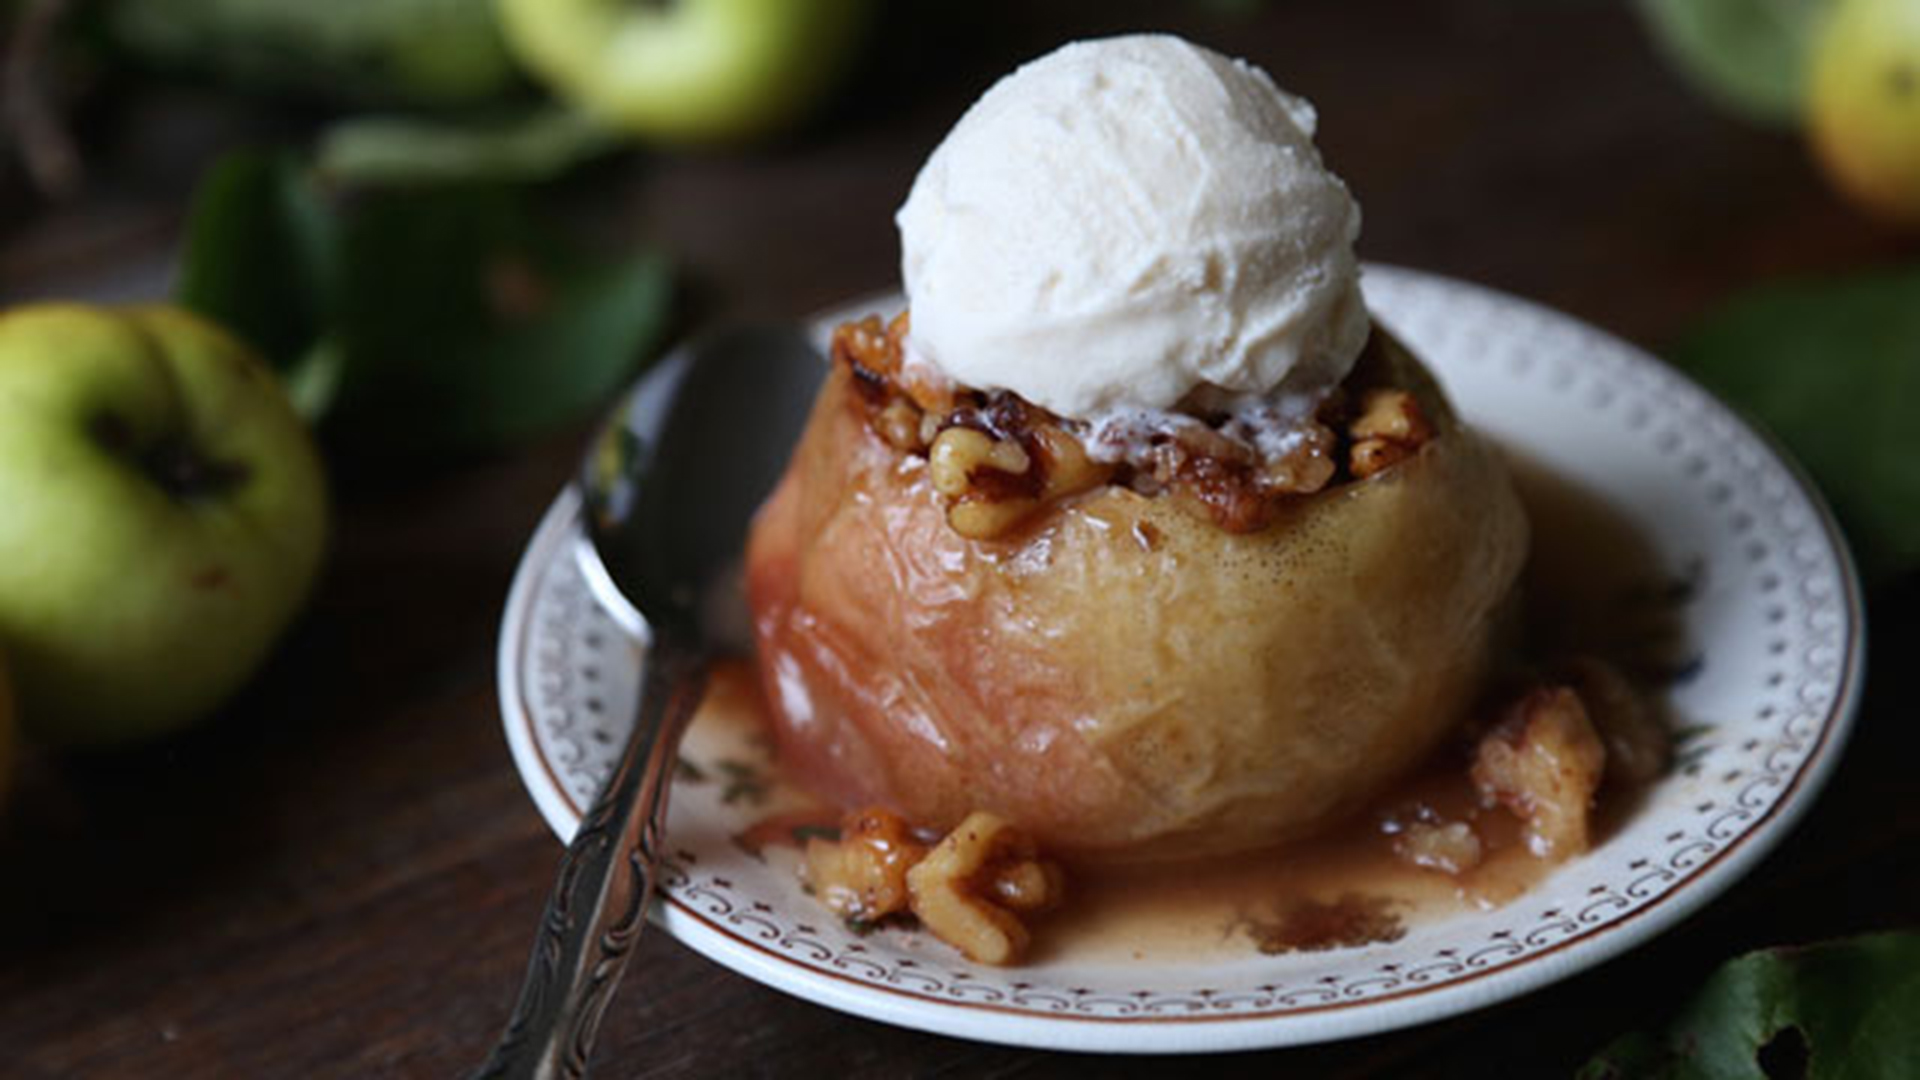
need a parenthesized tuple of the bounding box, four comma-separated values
(497, 263, 1866, 1053)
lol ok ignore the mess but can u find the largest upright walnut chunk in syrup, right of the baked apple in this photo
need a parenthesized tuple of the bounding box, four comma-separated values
(1473, 686, 1607, 859)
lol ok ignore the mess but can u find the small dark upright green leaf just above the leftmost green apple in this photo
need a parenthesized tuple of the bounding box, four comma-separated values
(173, 152, 334, 369)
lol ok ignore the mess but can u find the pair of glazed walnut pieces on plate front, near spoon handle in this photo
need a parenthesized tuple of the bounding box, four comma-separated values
(804, 807, 1066, 965)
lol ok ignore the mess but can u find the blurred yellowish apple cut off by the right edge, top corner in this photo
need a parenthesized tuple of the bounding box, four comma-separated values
(1807, 0, 1920, 227)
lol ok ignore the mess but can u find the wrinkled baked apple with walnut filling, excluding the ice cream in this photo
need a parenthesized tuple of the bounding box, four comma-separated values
(747, 319, 1526, 861)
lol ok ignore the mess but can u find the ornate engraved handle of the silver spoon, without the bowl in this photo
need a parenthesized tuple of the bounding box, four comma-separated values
(472, 636, 707, 1080)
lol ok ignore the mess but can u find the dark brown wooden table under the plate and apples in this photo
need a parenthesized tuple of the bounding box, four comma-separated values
(0, 0, 1920, 1078)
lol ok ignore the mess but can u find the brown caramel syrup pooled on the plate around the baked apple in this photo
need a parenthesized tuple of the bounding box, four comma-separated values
(685, 445, 1690, 963)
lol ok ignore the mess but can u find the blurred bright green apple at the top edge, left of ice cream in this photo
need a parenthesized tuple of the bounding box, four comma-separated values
(499, 0, 870, 140)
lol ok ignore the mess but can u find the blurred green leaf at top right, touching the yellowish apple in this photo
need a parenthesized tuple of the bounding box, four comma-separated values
(1638, 0, 1832, 127)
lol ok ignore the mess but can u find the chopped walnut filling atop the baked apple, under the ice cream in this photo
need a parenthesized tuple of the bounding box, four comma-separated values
(833, 311, 1434, 540)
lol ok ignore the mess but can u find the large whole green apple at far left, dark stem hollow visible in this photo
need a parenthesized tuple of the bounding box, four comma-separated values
(0, 304, 326, 746)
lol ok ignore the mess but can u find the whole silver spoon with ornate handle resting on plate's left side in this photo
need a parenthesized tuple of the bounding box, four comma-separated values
(474, 327, 826, 1080)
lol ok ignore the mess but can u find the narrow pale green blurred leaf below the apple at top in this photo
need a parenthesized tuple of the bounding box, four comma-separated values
(315, 106, 616, 184)
